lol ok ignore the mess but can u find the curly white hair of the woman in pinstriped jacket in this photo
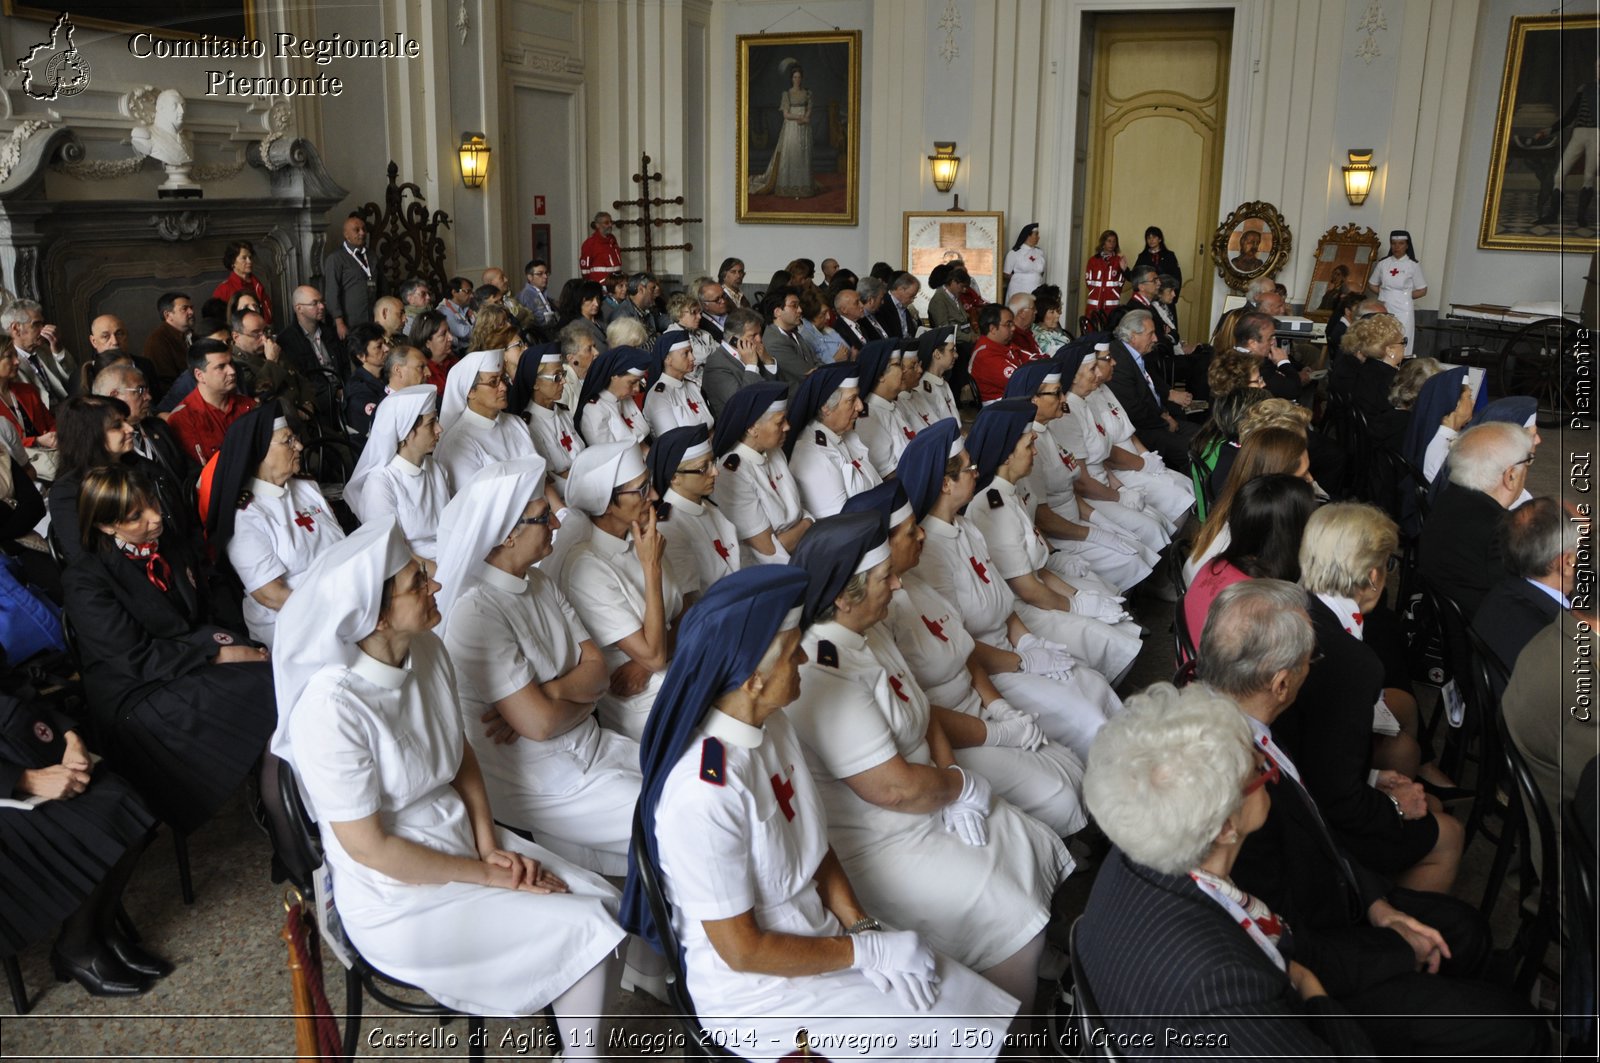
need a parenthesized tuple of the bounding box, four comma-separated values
(1083, 684, 1253, 874)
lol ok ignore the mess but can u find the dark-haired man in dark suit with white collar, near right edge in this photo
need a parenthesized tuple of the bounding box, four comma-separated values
(1472, 498, 1581, 684)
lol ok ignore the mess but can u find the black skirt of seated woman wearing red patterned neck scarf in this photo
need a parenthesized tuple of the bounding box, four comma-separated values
(104, 661, 278, 832)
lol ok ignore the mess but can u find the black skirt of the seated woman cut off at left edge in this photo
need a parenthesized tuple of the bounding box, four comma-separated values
(0, 765, 155, 956)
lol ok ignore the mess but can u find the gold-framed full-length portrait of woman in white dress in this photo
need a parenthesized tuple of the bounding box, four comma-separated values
(734, 30, 861, 226)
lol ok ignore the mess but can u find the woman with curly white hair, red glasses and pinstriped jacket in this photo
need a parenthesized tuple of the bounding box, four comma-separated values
(1075, 684, 1371, 1058)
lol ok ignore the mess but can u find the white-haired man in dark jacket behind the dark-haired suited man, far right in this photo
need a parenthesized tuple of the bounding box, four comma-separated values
(1419, 421, 1533, 616)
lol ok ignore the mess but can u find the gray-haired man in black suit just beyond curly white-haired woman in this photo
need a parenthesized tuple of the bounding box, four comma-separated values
(1197, 580, 1542, 1058)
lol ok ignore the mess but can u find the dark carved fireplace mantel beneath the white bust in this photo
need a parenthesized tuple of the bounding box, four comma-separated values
(0, 128, 347, 352)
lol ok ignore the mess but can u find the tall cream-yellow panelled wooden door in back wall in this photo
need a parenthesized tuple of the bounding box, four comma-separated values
(1077, 11, 1234, 343)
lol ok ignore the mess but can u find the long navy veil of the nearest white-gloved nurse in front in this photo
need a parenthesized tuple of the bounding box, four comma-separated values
(621, 565, 806, 953)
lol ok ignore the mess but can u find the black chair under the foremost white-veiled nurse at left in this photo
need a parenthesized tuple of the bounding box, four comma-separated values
(261, 752, 485, 1060)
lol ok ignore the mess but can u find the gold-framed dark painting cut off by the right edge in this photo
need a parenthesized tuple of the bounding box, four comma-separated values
(1478, 14, 1600, 255)
